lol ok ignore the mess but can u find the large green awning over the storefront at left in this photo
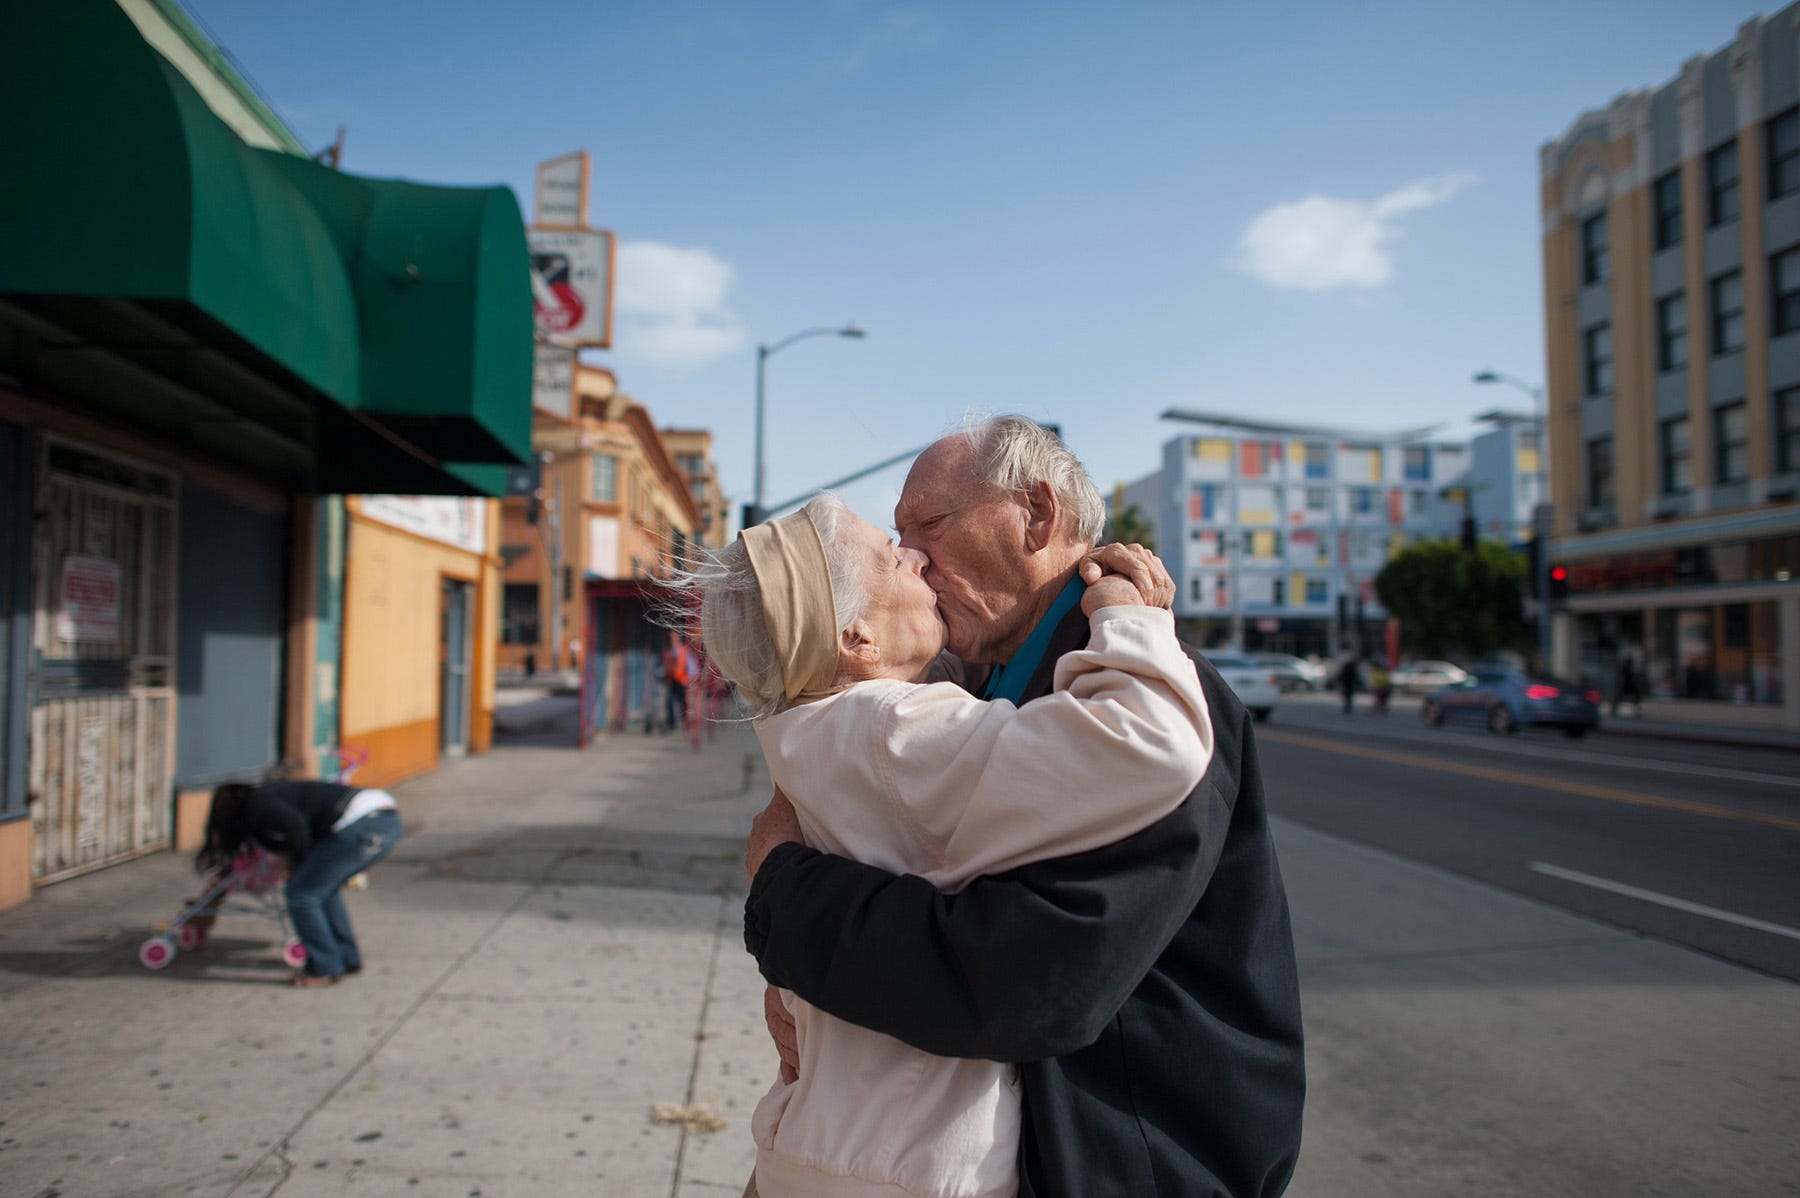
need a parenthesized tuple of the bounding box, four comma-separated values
(0, 0, 531, 493)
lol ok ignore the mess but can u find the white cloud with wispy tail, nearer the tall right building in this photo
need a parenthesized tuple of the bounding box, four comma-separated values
(1229, 174, 1471, 291)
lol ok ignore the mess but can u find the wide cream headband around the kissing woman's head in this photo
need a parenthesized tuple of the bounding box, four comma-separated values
(738, 511, 837, 702)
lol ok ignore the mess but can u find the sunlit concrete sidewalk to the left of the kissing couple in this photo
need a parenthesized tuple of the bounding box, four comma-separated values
(0, 708, 774, 1198)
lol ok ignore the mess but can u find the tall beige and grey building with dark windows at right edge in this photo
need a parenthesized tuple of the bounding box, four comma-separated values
(1541, 5, 1800, 727)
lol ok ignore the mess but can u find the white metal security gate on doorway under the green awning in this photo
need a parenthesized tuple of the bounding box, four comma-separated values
(29, 439, 176, 883)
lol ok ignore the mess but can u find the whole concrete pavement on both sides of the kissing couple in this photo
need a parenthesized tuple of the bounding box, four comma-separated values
(0, 694, 1800, 1198)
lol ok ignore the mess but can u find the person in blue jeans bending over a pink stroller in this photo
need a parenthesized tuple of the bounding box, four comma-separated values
(194, 781, 400, 988)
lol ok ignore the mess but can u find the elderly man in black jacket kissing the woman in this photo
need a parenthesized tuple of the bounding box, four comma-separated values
(745, 416, 1305, 1198)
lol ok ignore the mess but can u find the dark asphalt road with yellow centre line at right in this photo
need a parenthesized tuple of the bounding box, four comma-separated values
(1258, 694, 1800, 980)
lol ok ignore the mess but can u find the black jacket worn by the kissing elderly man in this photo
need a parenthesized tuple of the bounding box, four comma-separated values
(745, 610, 1305, 1198)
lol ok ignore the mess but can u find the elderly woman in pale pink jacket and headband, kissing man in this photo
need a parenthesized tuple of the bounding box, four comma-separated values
(688, 495, 1211, 1198)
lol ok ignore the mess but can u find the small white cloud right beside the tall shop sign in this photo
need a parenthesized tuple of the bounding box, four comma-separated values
(614, 241, 749, 371)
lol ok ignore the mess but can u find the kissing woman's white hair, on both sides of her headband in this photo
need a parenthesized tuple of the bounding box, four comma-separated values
(668, 491, 866, 720)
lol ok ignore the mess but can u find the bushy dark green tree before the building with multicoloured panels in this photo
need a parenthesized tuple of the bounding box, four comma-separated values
(1375, 540, 1530, 660)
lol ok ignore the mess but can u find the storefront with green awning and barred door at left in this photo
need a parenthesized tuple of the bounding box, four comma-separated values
(0, 0, 531, 907)
